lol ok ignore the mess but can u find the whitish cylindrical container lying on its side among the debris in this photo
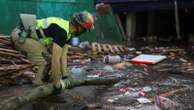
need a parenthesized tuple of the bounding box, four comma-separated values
(103, 55, 122, 63)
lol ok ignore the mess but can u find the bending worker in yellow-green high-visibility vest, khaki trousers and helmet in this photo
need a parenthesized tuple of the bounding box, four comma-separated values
(11, 11, 94, 92)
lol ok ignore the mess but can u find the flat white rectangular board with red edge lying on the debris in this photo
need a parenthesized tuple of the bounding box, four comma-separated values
(131, 54, 167, 64)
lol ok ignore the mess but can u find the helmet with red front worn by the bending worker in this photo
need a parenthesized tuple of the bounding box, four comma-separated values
(73, 11, 94, 31)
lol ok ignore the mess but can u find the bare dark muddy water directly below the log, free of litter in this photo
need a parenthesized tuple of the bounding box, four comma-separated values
(29, 86, 101, 110)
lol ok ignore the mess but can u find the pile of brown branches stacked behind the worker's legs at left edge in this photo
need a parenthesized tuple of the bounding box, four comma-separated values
(0, 37, 33, 85)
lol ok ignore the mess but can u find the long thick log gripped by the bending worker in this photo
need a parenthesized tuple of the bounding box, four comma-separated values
(0, 78, 121, 110)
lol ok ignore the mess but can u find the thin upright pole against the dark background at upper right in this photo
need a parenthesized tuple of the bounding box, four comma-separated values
(174, 0, 181, 40)
